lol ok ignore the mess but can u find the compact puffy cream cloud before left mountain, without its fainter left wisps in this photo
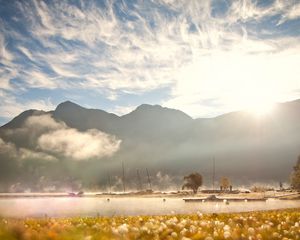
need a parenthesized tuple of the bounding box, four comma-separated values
(23, 114, 121, 160)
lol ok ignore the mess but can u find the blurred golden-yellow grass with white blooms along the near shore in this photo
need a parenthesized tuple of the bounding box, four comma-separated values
(0, 209, 300, 240)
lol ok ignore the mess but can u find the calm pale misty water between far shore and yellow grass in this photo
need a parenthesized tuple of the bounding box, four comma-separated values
(0, 197, 300, 217)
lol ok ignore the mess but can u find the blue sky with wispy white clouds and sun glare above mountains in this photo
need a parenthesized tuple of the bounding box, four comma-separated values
(0, 0, 300, 125)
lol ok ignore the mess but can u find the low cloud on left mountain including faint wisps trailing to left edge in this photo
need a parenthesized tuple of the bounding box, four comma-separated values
(0, 113, 121, 161)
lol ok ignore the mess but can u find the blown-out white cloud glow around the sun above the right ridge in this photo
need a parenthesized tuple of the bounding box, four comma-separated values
(163, 44, 300, 117)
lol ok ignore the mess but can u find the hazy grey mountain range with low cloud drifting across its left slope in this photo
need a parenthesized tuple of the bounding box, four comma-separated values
(0, 100, 300, 188)
